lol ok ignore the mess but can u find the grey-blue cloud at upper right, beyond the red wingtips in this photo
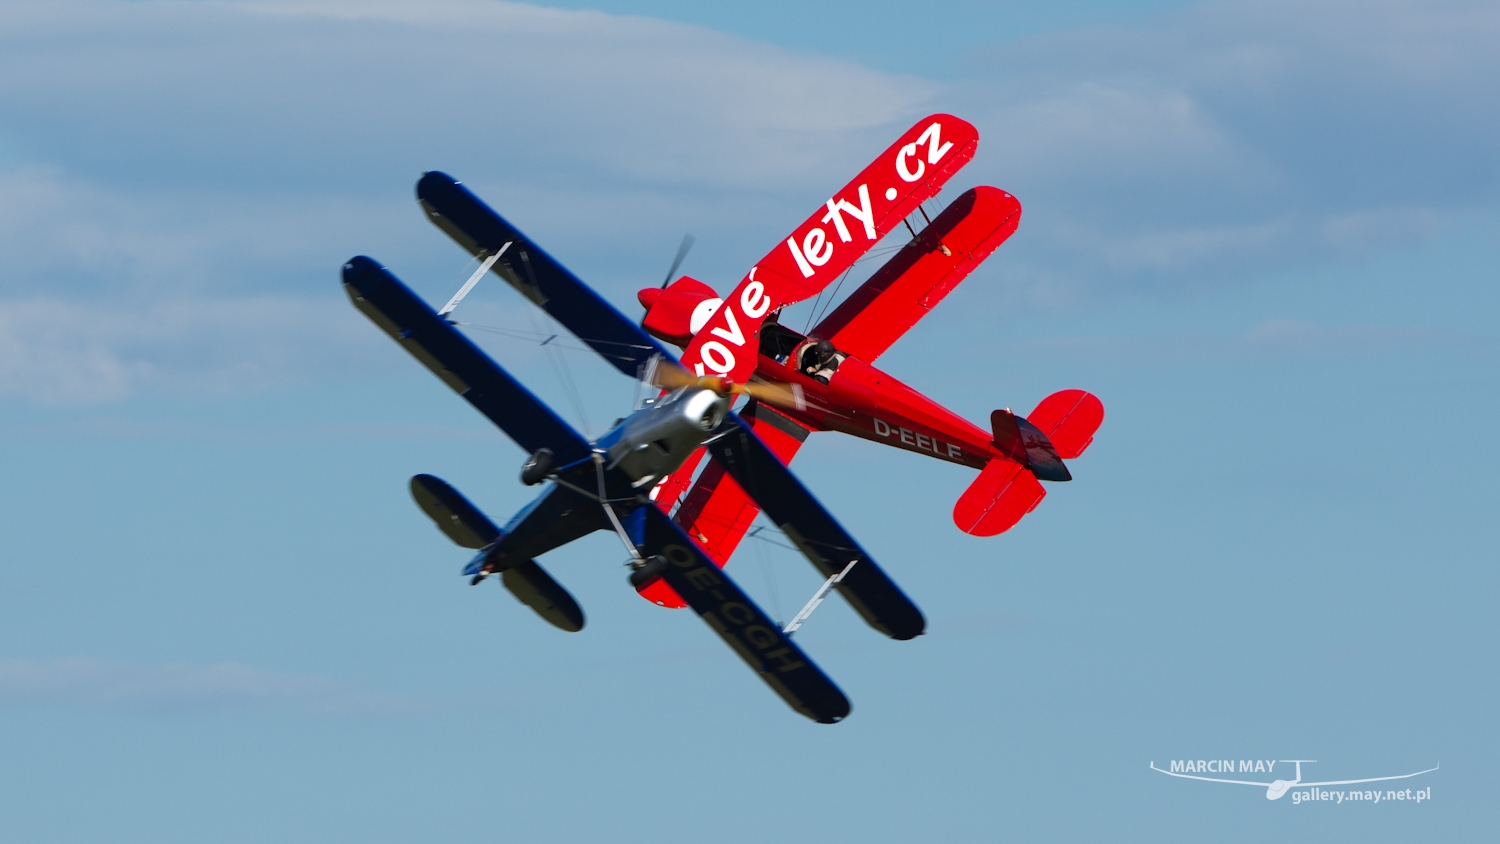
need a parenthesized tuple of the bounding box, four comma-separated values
(956, 0, 1500, 298)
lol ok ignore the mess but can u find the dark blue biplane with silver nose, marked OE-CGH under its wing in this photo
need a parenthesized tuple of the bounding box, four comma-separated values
(344, 172, 926, 724)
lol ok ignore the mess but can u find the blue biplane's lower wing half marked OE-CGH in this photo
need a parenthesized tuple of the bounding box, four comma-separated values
(641, 505, 849, 724)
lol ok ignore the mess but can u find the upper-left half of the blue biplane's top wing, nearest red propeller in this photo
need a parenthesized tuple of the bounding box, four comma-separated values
(417, 171, 677, 378)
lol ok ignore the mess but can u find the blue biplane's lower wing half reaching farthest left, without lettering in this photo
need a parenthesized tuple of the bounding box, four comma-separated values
(344, 255, 590, 463)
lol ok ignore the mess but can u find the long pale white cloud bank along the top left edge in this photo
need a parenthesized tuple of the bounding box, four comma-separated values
(0, 0, 935, 187)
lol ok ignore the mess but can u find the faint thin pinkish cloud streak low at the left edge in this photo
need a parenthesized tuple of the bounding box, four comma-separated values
(0, 658, 425, 717)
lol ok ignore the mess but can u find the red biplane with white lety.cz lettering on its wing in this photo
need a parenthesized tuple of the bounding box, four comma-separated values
(638, 114, 1104, 607)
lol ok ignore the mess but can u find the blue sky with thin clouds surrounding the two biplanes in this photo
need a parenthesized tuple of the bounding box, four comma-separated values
(0, 0, 1500, 841)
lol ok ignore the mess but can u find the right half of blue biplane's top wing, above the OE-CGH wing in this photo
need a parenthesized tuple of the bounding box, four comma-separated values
(708, 414, 927, 639)
